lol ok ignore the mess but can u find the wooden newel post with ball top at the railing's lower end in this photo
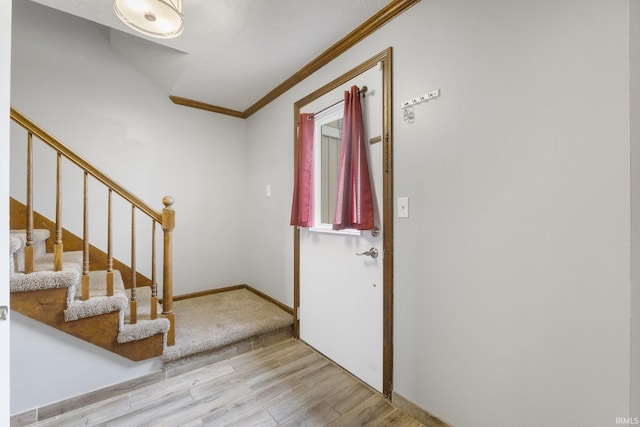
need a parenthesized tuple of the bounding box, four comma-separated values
(162, 196, 176, 345)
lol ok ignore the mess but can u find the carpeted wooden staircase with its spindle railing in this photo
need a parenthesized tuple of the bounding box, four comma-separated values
(9, 109, 175, 361)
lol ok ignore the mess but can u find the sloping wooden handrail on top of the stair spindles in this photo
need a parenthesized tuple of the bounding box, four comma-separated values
(11, 107, 162, 223)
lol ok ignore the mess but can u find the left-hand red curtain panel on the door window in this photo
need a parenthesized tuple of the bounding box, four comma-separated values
(291, 113, 314, 227)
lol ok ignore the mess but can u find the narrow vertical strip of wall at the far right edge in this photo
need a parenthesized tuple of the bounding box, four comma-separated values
(629, 1, 640, 418)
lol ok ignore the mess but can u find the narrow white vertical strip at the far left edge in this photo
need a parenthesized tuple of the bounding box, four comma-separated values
(0, 2, 11, 426)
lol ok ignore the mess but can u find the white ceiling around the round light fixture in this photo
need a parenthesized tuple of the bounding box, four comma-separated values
(32, 0, 389, 111)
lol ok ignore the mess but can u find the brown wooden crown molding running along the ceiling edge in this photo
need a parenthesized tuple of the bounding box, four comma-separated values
(169, 0, 420, 119)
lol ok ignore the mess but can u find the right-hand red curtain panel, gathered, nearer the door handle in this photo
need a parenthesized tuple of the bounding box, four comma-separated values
(333, 86, 374, 230)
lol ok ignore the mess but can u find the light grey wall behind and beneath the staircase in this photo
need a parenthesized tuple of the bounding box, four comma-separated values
(10, 1, 247, 414)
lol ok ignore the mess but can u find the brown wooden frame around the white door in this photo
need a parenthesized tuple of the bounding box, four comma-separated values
(293, 47, 393, 398)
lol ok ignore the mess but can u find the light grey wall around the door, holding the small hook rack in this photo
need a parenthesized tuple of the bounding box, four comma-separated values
(247, 0, 630, 427)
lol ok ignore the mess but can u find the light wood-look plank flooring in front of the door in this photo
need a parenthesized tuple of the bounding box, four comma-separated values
(35, 339, 423, 427)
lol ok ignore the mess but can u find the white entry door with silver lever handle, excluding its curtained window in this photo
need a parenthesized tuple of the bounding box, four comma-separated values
(299, 67, 384, 392)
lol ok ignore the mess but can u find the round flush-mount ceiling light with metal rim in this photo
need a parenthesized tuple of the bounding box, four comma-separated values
(113, 0, 184, 39)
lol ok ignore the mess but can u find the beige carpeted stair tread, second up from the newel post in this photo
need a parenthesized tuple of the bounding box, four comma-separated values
(64, 270, 129, 322)
